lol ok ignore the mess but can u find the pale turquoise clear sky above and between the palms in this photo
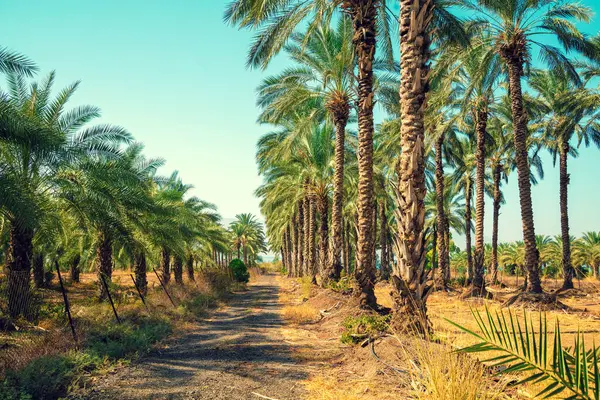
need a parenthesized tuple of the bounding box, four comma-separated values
(0, 0, 600, 247)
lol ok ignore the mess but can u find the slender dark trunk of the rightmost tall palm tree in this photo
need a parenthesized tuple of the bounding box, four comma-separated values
(559, 143, 575, 289)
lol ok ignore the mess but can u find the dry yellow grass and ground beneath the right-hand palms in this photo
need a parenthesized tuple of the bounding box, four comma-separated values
(279, 277, 600, 400)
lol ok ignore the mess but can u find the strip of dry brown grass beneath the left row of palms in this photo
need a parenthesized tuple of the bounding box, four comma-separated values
(0, 271, 230, 378)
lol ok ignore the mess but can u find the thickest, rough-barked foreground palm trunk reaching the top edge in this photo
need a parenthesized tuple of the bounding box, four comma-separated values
(392, 0, 433, 335)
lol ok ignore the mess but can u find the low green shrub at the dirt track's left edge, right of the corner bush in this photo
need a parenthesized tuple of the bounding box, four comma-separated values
(86, 318, 171, 359)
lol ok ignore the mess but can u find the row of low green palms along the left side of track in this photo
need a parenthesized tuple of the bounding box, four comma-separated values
(0, 48, 264, 317)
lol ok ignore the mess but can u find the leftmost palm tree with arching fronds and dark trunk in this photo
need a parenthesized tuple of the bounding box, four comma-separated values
(0, 72, 132, 306)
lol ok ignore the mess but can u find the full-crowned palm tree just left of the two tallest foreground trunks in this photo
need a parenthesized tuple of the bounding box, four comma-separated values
(258, 18, 354, 280)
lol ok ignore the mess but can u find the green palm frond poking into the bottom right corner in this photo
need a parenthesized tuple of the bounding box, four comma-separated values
(447, 307, 600, 400)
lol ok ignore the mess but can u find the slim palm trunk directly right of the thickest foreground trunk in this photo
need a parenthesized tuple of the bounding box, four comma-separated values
(435, 133, 450, 288)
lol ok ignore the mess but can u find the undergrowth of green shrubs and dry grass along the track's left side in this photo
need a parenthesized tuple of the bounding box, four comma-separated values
(0, 271, 237, 400)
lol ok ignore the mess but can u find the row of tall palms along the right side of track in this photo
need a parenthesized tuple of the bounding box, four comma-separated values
(225, 0, 600, 333)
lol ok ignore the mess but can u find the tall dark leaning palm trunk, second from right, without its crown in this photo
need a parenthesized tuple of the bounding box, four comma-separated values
(502, 57, 542, 293)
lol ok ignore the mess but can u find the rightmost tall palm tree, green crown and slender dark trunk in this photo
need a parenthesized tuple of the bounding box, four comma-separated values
(529, 71, 600, 289)
